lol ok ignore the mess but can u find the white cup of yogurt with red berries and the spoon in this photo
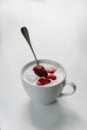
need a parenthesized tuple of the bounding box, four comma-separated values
(21, 27, 76, 105)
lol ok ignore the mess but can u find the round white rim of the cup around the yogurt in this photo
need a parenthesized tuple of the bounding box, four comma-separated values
(21, 59, 67, 88)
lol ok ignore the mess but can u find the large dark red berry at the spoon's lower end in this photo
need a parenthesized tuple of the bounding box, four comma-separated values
(33, 65, 48, 77)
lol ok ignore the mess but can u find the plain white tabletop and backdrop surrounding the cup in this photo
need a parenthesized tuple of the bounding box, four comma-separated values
(0, 0, 87, 130)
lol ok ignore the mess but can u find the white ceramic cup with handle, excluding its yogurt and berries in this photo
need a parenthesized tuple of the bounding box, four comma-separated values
(21, 59, 76, 105)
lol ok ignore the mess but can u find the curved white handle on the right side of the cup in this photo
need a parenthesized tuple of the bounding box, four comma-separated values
(59, 81, 76, 97)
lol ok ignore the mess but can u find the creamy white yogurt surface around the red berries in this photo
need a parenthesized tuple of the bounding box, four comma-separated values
(23, 63, 64, 86)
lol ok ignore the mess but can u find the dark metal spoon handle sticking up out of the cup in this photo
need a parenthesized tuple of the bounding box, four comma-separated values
(21, 27, 39, 65)
